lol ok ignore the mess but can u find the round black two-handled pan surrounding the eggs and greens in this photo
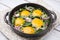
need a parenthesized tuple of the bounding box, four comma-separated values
(4, 3, 57, 38)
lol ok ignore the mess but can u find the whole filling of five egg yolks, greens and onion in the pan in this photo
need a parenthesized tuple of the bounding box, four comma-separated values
(12, 6, 49, 34)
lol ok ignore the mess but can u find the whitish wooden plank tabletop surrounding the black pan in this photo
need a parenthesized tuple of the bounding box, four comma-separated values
(0, 0, 60, 40)
